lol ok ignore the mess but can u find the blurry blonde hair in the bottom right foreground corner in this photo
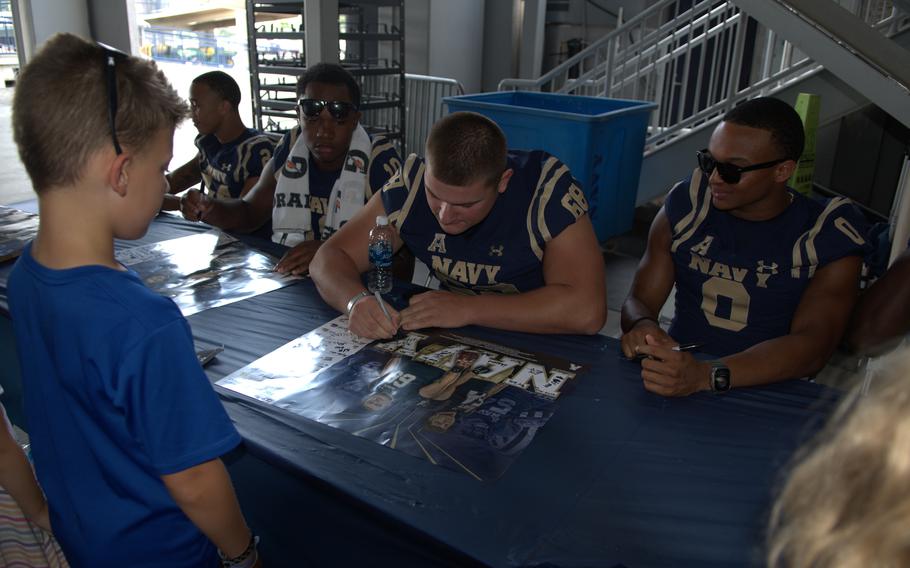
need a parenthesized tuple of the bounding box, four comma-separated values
(768, 348, 910, 568)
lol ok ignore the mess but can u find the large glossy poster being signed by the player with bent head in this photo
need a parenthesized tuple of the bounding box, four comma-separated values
(217, 316, 583, 480)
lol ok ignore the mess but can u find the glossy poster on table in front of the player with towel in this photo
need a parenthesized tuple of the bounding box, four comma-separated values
(116, 230, 300, 316)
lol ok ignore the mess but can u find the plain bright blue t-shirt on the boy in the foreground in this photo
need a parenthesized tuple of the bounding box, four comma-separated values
(8, 245, 240, 568)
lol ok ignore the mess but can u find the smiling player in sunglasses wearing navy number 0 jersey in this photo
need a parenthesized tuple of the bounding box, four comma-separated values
(622, 98, 868, 396)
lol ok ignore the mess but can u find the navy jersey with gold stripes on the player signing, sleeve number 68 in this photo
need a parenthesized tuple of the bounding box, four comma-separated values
(382, 151, 588, 293)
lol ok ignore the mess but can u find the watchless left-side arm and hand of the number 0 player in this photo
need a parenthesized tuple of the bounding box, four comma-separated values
(620, 207, 676, 358)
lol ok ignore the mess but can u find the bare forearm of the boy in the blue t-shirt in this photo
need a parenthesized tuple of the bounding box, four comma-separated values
(161, 458, 251, 558)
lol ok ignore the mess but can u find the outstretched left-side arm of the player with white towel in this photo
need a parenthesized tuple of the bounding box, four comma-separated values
(180, 159, 278, 233)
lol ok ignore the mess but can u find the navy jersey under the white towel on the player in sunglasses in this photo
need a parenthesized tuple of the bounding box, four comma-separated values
(272, 126, 401, 240)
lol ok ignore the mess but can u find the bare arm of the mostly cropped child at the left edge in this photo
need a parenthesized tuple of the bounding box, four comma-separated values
(0, 406, 51, 532)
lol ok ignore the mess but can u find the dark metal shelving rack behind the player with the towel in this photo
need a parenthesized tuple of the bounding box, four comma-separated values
(247, 0, 405, 144)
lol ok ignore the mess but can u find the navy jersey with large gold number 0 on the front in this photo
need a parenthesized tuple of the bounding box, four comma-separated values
(664, 170, 868, 356)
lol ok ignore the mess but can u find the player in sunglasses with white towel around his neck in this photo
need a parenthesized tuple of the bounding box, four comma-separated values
(182, 63, 401, 274)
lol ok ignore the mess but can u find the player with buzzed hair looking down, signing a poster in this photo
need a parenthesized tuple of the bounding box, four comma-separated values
(311, 112, 606, 338)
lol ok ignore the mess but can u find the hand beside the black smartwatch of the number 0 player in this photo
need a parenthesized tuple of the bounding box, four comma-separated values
(637, 334, 711, 396)
